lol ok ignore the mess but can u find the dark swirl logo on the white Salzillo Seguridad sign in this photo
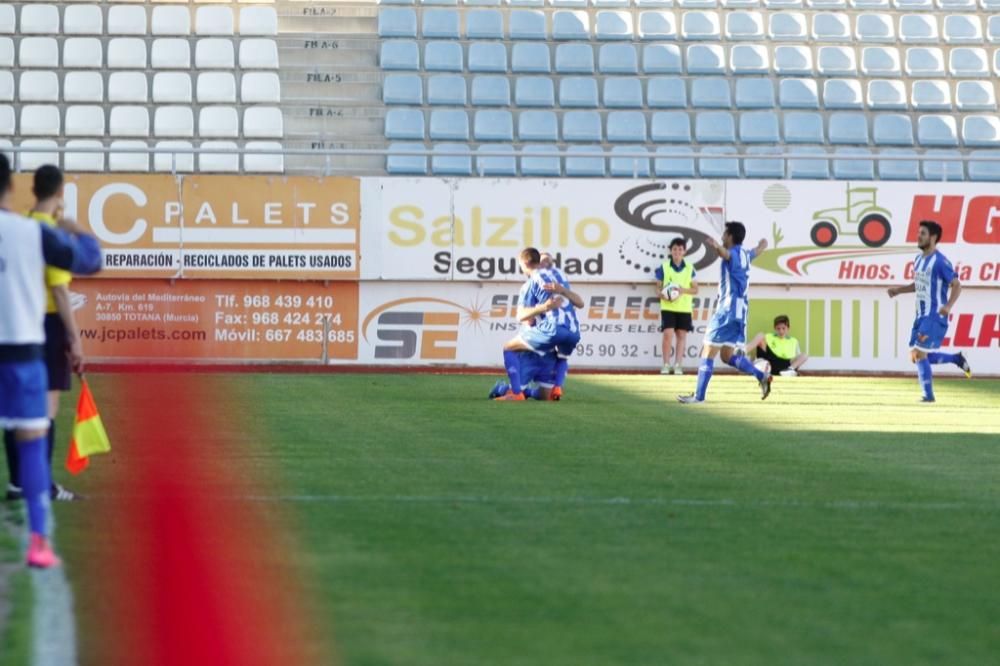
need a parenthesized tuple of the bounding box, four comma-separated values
(615, 183, 723, 274)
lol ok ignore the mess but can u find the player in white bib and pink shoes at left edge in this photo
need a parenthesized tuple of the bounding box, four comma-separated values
(0, 155, 101, 568)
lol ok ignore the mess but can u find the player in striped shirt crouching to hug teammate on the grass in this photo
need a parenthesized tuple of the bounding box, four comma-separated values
(497, 247, 580, 400)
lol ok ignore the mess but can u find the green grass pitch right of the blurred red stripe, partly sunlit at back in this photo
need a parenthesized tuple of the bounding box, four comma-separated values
(59, 374, 1000, 666)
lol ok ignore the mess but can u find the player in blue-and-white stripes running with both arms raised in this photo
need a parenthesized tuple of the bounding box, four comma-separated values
(677, 222, 771, 404)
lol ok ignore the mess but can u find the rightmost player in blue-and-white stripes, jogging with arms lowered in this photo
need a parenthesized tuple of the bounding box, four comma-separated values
(889, 220, 972, 402)
